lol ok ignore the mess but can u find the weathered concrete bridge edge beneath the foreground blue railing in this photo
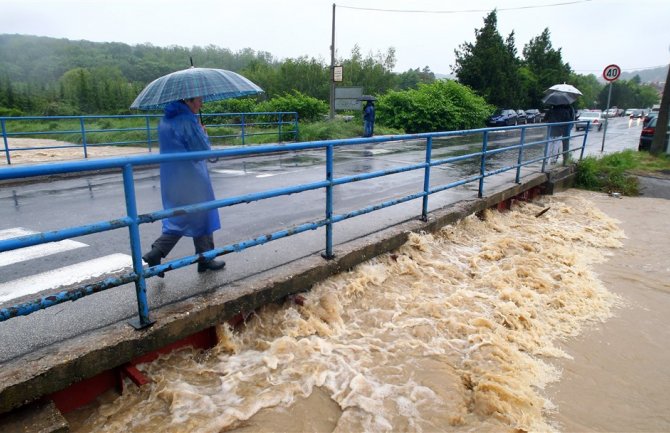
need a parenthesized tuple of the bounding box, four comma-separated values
(0, 166, 575, 418)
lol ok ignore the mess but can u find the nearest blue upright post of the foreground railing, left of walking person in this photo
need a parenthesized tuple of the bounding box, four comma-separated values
(123, 164, 154, 329)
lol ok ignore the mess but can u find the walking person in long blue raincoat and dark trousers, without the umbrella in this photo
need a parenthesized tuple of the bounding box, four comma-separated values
(142, 98, 226, 278)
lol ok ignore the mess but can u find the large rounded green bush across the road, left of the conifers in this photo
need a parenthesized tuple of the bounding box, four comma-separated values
(377, 80, 492, 133)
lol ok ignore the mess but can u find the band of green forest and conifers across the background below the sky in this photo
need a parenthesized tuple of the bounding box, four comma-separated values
(0, 11, 658, 122)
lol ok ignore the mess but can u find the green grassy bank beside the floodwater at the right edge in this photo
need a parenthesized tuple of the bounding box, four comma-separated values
(575, 150, 670, 196)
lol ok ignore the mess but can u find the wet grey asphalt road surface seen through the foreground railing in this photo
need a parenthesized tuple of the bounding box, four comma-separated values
(0, 119, 641, 362)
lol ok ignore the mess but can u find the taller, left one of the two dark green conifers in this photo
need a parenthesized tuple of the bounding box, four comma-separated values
(452, 10, 520, 107)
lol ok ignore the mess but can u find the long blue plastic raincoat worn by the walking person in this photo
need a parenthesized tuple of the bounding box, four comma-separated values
(158, 101, 221, 237)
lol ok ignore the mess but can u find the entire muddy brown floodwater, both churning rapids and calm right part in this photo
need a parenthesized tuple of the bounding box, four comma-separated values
(60, 190, 670, 432)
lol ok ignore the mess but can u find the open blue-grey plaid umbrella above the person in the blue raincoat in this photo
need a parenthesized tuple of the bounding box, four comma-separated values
(130, 67, 263, 110)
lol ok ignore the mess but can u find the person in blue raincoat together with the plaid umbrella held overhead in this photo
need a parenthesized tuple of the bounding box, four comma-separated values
(131, 67, 263, 278)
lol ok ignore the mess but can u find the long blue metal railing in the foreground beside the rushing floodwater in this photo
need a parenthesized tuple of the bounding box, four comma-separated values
(0, 122, 588, 328)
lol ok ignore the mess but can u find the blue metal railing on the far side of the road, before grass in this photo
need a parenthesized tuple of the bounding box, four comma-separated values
(0, 112, 298, 165)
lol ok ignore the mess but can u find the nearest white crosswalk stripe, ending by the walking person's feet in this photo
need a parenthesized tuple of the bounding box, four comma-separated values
(0, 254, 133, 302)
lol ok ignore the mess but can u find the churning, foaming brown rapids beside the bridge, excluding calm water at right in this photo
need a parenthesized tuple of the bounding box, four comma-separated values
(77, 196, 624, 433)
